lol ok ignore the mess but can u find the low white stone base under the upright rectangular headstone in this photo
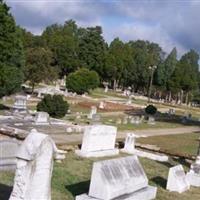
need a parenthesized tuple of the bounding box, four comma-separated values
(75, 149, 119, 158)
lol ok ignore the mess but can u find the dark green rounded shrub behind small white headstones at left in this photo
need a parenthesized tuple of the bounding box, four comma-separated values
(37, 95, 69, 118)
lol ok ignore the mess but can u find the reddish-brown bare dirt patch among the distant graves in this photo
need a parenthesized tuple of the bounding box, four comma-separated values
(78, 101, 134, 112)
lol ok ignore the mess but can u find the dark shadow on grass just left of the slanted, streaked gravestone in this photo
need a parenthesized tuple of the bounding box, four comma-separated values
(65, 180, 90, 197)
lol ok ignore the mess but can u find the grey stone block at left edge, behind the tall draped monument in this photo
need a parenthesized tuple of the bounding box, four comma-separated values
(0, 140, 20, 171)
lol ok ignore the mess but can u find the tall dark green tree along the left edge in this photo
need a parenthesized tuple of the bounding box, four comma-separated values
(0, 0, 25, 97)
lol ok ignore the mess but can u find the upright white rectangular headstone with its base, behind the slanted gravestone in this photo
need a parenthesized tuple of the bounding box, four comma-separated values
(76, 125, 119, 157)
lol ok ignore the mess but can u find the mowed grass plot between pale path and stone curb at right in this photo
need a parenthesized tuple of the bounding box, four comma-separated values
(136, 133, 200, 156)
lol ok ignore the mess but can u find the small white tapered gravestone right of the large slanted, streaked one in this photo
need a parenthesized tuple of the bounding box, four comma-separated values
(167, 165, 190, 193)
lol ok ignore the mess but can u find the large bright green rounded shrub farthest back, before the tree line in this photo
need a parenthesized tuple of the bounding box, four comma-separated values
(66, 68, 99, 94)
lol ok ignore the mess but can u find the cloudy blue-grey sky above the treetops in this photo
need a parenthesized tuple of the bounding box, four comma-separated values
(5, 0, 200, 56)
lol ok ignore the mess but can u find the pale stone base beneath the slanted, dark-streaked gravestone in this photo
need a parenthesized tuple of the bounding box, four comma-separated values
(76, 186, 157, 200)
